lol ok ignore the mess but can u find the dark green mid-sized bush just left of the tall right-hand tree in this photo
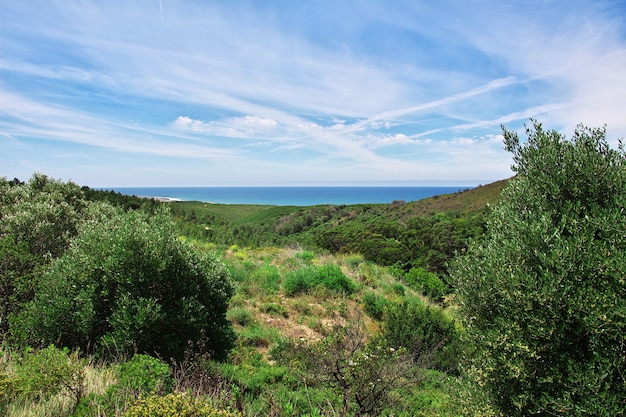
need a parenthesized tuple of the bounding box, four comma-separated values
(383, 298, 464, 374)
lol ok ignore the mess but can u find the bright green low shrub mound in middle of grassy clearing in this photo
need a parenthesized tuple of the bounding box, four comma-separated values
(283, 264, 356, 295)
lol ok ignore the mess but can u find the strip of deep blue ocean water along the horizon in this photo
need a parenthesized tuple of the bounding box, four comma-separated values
(106, 186, 470, 206)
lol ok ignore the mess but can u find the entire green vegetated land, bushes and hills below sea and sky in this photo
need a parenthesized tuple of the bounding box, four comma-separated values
(0, 119, 626, 417)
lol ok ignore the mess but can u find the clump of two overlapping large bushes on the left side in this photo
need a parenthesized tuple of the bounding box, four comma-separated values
(0, 175, 233, 359)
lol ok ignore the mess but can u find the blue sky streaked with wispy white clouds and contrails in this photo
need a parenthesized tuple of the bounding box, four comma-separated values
(0, 0, 626, 187)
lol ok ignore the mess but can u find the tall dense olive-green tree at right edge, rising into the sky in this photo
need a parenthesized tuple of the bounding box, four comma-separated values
(452, 122, 626, 416)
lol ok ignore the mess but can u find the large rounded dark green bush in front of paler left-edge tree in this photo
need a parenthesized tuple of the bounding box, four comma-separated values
(13, 205, 233, 358)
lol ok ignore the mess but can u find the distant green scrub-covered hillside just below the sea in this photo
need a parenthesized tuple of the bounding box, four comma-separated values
(170, 176, 508, 276)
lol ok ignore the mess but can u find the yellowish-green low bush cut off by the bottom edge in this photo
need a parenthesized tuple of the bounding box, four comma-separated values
(123, 393, 241, 417)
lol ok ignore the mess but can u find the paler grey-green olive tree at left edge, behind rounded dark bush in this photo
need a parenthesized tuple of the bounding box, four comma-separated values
(0, 174, 87, 333)
